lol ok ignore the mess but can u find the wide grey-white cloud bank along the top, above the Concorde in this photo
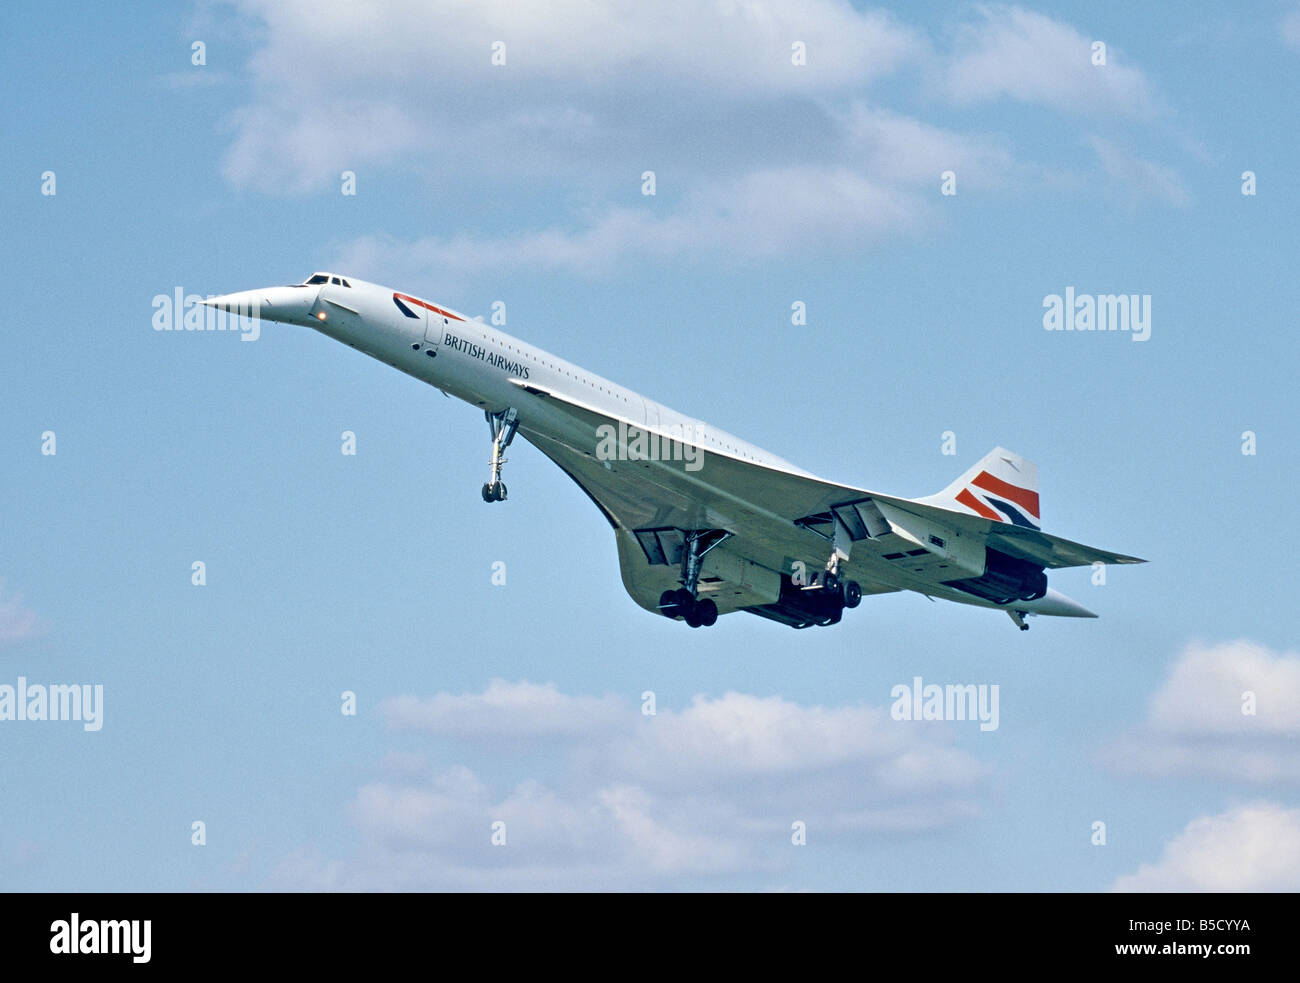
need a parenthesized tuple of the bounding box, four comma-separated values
(222, 0, 1186, 273)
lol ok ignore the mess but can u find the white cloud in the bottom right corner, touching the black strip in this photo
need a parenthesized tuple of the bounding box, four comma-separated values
(1112, 802, 1300, 892)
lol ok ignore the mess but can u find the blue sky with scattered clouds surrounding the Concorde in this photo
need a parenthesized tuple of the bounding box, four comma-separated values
(0, 0, 1300, 891)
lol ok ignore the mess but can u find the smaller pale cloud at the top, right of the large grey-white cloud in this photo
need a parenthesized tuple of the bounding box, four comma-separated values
(945, 4, 1157, 118)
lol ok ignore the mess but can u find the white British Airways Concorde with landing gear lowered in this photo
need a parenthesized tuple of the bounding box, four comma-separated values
(204, 273, 1144, 631)
